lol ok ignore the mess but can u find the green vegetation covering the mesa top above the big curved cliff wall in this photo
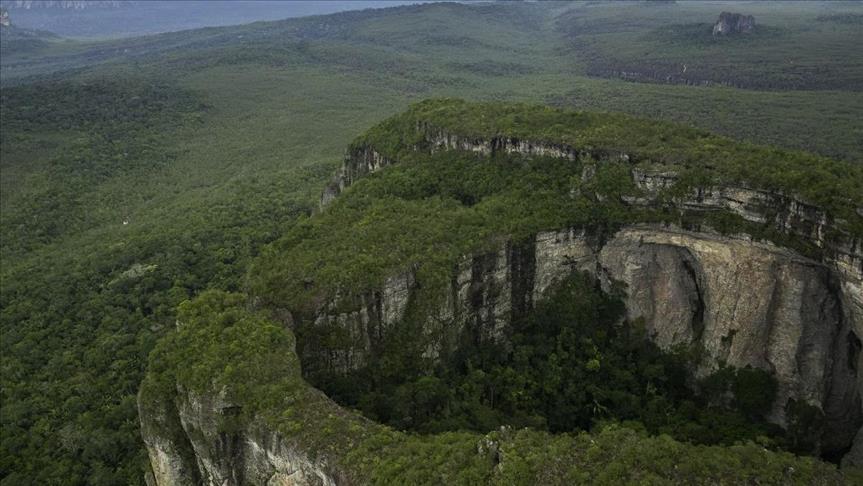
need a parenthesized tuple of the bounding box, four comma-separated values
(255, 100, 863, 316)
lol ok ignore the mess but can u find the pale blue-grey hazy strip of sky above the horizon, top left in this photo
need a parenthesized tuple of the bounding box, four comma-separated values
(0, 0, 438, 37)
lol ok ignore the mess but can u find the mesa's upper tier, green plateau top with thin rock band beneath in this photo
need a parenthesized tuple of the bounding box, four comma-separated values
(322, 100, 863, 236)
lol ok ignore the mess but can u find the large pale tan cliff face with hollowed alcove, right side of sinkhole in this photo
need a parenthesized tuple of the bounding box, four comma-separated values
(599, 228, 863, 454)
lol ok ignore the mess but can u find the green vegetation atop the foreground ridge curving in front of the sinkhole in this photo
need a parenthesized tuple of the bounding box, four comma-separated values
(141, 292, 860, 484)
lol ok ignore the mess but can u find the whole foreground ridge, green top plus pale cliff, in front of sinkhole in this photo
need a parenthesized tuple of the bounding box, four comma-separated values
(138, 291, 855, 486)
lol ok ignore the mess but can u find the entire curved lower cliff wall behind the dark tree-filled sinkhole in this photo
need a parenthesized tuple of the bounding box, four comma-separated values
(300, 225, 863, 460)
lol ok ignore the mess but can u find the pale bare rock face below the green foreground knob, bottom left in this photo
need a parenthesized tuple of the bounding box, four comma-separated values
(139, 387, 336, 486)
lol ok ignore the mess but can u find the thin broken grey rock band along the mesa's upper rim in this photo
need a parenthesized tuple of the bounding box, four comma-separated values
(321, 117, 863, 274)
